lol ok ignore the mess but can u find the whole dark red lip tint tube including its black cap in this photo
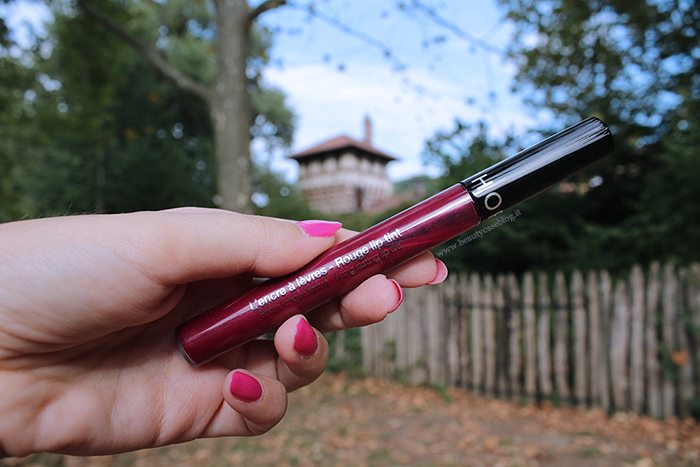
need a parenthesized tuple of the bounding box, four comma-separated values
(176, 118, 614, 366)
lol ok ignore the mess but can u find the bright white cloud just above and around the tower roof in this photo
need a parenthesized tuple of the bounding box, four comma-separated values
(266, 59, 525, 180)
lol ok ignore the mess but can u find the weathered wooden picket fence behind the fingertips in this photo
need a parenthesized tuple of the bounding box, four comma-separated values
(362, 263, 700, 418)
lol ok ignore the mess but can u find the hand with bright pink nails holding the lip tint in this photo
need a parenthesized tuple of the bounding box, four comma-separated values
(0, 208, 446, 457)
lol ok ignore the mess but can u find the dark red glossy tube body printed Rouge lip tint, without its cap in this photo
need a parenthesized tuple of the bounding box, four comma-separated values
(178, 185, 480, 366)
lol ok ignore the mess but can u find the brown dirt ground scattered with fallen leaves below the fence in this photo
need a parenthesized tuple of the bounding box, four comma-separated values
(5, 375, 700, 467)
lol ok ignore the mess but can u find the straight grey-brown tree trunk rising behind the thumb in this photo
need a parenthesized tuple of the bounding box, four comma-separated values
(215, 0, 253, 213)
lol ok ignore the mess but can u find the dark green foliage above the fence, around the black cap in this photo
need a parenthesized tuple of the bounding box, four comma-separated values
(418, 0, 700, 273)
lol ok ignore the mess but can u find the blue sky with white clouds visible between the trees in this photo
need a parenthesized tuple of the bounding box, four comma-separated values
(0, 0, 534, 181)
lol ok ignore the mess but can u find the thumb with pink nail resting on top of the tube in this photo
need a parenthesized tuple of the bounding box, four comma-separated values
(121, 208, 341, 284)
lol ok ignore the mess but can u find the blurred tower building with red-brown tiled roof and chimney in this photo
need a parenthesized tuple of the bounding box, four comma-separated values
(291, 117, 396, 214)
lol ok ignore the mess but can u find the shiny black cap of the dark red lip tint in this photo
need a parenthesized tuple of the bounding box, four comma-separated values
(462, 117, 615, 218)
